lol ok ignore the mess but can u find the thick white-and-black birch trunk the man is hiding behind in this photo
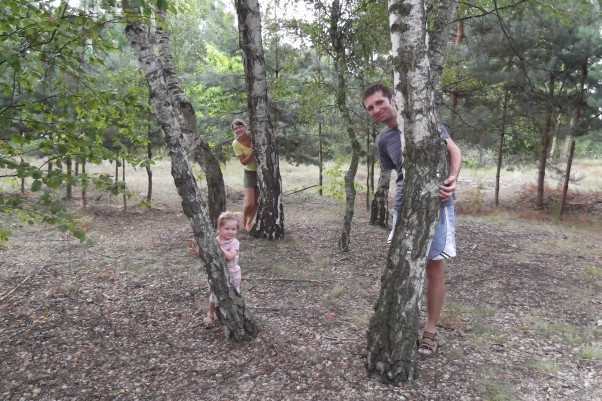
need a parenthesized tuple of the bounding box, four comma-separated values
(366, 0, 453, 383)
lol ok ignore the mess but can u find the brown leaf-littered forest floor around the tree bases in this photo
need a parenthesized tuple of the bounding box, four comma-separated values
(0, 170, 602, 401)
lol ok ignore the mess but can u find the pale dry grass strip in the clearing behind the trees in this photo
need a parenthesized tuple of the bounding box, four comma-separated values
(0, 157, 602, 226)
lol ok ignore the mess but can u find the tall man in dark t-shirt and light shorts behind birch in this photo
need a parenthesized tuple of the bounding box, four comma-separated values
(362, 84, 462, 356)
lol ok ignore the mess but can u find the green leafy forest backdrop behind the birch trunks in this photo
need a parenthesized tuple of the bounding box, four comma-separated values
(0, 1, 601, 398)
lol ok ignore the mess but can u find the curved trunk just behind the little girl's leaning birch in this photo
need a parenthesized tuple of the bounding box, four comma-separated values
(156, 11, 226, 227)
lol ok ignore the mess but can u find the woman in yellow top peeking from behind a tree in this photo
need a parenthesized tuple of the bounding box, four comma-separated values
(231, 120, 257, 231)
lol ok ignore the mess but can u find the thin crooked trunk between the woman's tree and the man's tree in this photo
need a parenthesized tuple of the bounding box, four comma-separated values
(330, 0, 361, 252)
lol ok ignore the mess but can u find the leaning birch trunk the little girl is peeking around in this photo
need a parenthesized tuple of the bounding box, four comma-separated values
(122, 0, 257, 340)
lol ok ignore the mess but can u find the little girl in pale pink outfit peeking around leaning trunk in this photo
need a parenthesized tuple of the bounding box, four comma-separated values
(203, 212, 241, 326)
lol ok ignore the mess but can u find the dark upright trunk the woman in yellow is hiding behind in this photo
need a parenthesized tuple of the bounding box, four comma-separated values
(236, 0, 284, 240)
